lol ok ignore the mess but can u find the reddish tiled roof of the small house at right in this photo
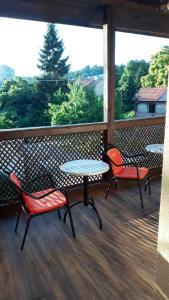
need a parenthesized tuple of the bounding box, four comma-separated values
(134, 87, 167, 101)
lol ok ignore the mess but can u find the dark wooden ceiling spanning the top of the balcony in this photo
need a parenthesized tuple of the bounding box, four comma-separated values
(0, 0, 169, 34)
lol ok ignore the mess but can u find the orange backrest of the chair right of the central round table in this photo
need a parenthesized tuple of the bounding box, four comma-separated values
(107, 148, 124, 176)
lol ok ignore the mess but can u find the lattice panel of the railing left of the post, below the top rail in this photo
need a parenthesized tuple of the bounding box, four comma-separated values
(0, 131, 104, 206)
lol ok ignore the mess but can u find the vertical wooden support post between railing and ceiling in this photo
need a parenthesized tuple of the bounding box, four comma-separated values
(103, 5, 115, 144)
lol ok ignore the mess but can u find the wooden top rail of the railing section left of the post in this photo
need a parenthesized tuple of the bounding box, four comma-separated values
(0, 123, 107, 141)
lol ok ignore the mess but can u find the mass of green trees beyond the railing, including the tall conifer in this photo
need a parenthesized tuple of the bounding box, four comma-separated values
(0, 24, 169, 128)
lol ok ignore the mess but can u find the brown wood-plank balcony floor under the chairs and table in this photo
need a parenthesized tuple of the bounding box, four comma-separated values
(0, 181, 160, 300)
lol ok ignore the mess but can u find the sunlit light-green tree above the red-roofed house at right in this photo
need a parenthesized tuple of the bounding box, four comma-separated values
(141, 46, 169, 87)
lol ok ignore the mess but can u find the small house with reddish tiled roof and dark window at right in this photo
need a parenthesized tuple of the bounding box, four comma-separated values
(133, 87, 167, 118)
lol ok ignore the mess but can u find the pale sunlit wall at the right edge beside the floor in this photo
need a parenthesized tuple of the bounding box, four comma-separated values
(154, 83, 169, 300)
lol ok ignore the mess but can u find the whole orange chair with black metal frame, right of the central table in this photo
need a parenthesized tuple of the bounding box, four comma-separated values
(105, 147, 151, 209)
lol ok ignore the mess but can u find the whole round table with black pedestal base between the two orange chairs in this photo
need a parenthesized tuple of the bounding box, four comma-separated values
(59, 159, 109, 229)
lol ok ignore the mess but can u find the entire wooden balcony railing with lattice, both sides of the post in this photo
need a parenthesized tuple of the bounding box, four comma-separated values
(0, 117, 165, 207)
